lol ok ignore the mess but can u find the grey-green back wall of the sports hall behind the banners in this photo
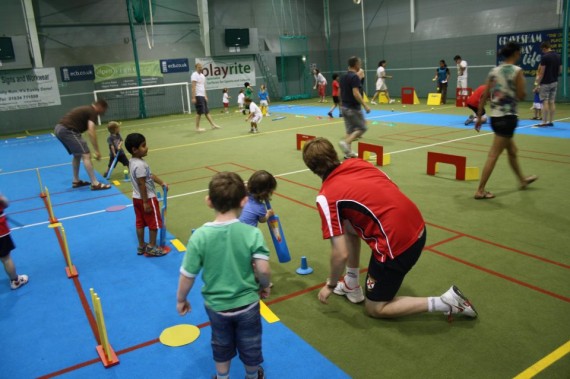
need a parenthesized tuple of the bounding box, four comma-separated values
(0, 0, 561, 134)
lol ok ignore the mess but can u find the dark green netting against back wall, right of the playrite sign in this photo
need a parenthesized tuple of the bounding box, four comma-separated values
(276, 36, 312, 101)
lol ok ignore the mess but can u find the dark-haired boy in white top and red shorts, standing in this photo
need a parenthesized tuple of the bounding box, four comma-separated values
(125, 133, 168, 257)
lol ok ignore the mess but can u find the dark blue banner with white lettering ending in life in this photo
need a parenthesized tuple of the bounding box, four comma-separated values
(497, 29, 562, 76)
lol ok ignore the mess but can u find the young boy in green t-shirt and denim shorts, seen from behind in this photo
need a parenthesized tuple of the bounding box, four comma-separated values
(176, 172, 271, 379)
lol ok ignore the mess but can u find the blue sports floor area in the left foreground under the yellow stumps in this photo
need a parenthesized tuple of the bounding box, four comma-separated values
(0, 134, 348, 378)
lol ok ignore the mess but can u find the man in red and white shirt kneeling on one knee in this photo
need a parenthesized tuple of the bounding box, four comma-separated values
(303, 138, 477, 318)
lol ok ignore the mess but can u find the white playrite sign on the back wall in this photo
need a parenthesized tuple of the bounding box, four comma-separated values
(196, 58, 255, 90)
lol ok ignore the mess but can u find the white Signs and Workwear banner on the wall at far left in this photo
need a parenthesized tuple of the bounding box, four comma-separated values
(0, 67, 61, 111)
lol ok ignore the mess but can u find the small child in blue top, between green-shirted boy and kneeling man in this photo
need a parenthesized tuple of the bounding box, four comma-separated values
(239, 170, 277, 227)
